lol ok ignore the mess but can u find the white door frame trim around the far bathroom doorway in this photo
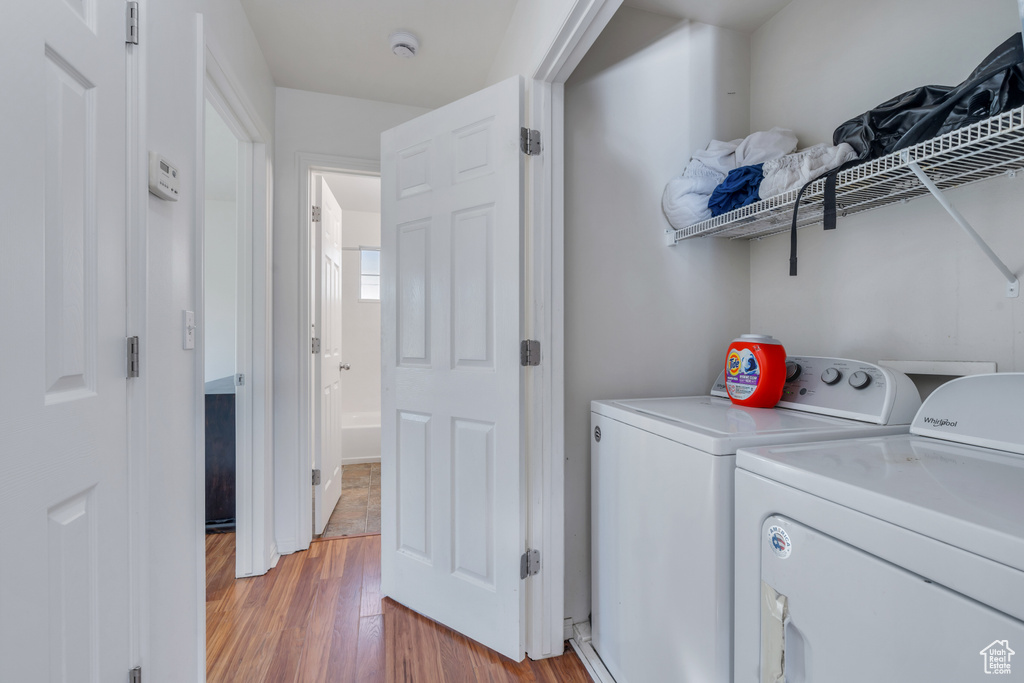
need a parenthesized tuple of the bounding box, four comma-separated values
(294, 152, 381, 549)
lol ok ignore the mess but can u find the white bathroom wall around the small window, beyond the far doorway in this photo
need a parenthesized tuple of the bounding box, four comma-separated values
(341, 209, 381, 419)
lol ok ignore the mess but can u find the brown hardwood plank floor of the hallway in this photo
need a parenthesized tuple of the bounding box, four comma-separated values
(206, 533, 591, 683)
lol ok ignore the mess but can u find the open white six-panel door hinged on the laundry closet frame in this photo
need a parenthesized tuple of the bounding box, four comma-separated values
(381, 77, 525, 660)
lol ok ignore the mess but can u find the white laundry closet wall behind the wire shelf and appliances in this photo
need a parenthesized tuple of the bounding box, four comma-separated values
(751, 0, 1024, 371)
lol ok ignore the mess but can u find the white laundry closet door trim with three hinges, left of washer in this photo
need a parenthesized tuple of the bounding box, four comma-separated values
(523, 0, 623, 659)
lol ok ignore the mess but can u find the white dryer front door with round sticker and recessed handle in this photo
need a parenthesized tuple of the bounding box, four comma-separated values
(761, 516, 1024, 683)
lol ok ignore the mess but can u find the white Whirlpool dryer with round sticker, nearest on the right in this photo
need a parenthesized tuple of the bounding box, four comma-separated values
(735, 374, 1024, 683)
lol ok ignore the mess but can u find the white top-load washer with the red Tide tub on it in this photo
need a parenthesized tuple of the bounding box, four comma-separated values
(591, 356, 921, 683)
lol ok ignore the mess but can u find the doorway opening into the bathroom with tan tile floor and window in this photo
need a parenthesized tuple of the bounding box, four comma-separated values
(309, 169, 381, 538)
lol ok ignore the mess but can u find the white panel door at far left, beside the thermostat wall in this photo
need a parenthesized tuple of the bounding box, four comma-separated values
(0, 0, 130, 683)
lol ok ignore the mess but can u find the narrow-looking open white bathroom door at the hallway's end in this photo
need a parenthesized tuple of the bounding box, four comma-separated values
(313, 175, 342, 533)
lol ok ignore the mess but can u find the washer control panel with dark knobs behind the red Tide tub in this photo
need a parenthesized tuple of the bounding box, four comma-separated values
(711, 355, 921, 424)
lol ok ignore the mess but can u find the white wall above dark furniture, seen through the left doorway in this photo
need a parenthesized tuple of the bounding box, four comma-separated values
(204, 200, 239, 382)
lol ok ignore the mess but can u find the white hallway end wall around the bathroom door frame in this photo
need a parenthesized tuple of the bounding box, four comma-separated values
(273, 88, 427, 552)
